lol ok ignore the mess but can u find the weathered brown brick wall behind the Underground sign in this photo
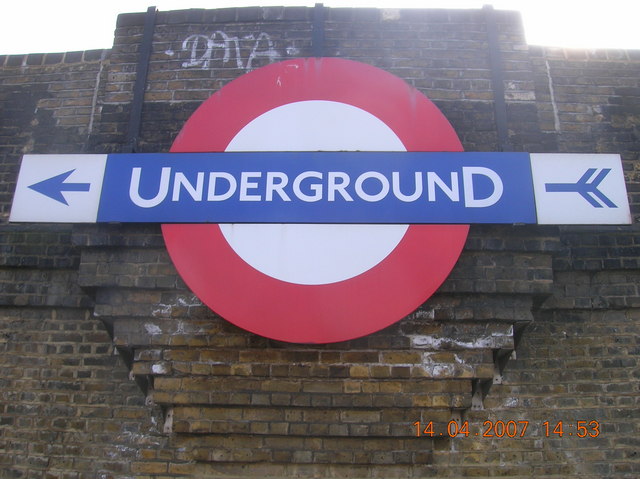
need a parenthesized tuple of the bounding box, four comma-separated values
(0, 7, 640, 478)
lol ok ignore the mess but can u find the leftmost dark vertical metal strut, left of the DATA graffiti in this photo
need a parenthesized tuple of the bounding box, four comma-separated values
(123, 7, 157, 153)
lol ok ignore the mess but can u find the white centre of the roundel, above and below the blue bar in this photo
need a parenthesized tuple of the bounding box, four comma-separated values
(220, 100, 408, 285)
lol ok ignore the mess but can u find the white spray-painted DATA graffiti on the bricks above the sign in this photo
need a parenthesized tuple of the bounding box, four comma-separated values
(171, 30, 281, 71)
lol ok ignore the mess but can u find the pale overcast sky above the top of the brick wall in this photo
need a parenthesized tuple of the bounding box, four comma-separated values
(0, 0, 640, 54)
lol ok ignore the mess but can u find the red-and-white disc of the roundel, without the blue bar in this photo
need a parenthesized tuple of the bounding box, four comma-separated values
(162, 58, 468, 343)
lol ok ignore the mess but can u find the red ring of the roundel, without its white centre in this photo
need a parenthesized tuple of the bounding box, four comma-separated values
(162, 58, 469, 343)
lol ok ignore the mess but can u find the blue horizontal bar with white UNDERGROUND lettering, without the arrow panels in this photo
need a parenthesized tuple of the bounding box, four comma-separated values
(98, 152, 536, 224)
